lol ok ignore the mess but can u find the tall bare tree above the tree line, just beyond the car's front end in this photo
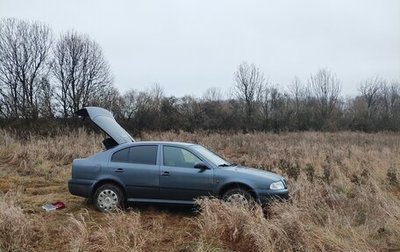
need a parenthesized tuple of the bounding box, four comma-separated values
(309, 69, 341, 126)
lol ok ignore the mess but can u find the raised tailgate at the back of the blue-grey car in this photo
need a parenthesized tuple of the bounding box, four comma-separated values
(75, 107, 135, 149)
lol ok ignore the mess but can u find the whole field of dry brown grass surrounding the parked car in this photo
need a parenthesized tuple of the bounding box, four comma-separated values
(0, 130, 400, 251)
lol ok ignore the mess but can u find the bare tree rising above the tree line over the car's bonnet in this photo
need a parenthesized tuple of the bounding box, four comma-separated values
(234, 62, 265, 123)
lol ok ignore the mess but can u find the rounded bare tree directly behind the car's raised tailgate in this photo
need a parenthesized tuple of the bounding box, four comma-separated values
(52, 32, 112, 117)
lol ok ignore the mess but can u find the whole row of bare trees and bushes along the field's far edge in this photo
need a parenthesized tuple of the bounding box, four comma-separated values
(0, 18, 400, 132)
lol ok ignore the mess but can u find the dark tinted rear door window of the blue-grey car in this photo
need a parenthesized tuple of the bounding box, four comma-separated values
(128, 145, 158, 165)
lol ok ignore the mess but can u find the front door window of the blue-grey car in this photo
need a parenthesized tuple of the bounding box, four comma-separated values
(163, 146, 201, 168)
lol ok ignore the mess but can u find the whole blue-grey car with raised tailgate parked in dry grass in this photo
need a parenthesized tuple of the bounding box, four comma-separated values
(68, 107, 288, 212)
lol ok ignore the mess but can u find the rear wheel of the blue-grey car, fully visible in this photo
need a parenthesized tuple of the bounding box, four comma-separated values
(93, 184, 125, 212)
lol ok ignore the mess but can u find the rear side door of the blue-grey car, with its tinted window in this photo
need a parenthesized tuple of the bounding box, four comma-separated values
(109, 145, 160, 200)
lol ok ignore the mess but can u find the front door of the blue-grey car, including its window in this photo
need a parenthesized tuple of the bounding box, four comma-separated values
(160, 145, 214, 201)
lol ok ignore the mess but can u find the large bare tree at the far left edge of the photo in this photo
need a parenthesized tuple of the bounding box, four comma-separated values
(0, 18, 52, 118)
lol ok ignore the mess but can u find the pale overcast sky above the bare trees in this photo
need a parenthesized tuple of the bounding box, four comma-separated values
(0, 0, 400, 96)
